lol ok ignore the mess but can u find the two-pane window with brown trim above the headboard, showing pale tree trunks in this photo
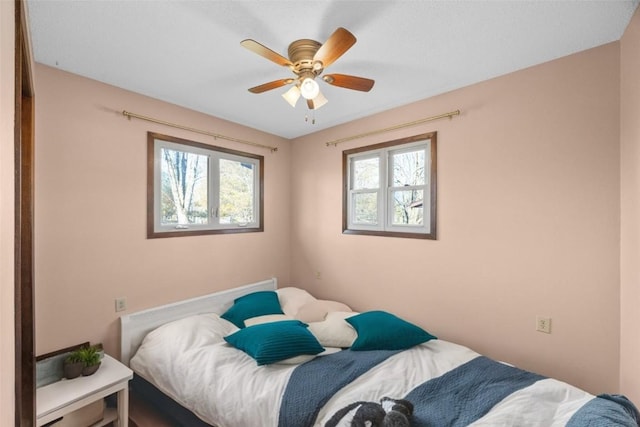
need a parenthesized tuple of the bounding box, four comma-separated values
(147, 132, 264, 238)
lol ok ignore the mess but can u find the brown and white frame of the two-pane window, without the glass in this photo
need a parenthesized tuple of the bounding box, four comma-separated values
(147, 132, 264, 239)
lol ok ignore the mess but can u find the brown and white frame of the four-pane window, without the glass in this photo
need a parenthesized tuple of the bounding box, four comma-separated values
(342, 132, 437, 240)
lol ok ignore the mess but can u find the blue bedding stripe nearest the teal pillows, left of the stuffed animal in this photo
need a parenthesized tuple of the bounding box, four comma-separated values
(278, 350, 400, 427)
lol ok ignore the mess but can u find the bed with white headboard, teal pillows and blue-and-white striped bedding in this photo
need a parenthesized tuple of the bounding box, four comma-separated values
(121, 279, 640, 427)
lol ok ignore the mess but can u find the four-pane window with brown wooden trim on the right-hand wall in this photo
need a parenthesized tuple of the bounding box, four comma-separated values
(342, 132, 436, 239)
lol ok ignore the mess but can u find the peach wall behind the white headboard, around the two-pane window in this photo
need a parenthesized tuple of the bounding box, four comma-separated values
(35, 65, 290, 355)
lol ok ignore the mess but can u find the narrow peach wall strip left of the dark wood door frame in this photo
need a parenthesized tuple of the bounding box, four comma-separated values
(0, 1, 15, 426)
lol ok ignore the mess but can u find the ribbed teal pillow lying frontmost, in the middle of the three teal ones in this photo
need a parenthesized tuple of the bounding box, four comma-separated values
(224, 320, 324, 365)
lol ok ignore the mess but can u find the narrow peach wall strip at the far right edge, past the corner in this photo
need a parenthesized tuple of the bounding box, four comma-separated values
(620, 6, 640, 402)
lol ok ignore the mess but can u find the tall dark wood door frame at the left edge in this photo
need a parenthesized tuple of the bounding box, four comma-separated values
(14, 0, 36, 427)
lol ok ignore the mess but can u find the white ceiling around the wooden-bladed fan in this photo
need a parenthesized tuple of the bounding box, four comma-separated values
(28, 0, 639, 138)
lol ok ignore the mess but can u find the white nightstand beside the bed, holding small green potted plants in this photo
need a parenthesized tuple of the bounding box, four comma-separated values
(36, 354, 133, 427)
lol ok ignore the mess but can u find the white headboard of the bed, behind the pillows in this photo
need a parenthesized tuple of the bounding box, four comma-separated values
(120, 277, 278, 366)
